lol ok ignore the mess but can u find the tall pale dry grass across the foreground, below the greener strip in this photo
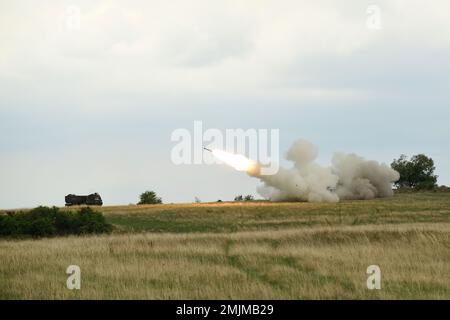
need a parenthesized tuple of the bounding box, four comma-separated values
(0, 223, 450, 299)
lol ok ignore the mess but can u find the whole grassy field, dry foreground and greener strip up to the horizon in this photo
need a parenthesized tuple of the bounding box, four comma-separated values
(0, 193, 450, 299)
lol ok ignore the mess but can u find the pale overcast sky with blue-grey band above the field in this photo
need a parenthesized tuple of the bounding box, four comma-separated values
(0, 0, 450, 208)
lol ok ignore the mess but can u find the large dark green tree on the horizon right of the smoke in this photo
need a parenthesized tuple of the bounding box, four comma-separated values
(391, 154, 437, 190)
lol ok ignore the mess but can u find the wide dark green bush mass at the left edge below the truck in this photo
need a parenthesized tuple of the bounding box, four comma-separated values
(0, 207, 112, 238)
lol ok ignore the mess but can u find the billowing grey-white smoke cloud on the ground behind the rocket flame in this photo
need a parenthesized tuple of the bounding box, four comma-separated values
(249, 140, 400, 202)
